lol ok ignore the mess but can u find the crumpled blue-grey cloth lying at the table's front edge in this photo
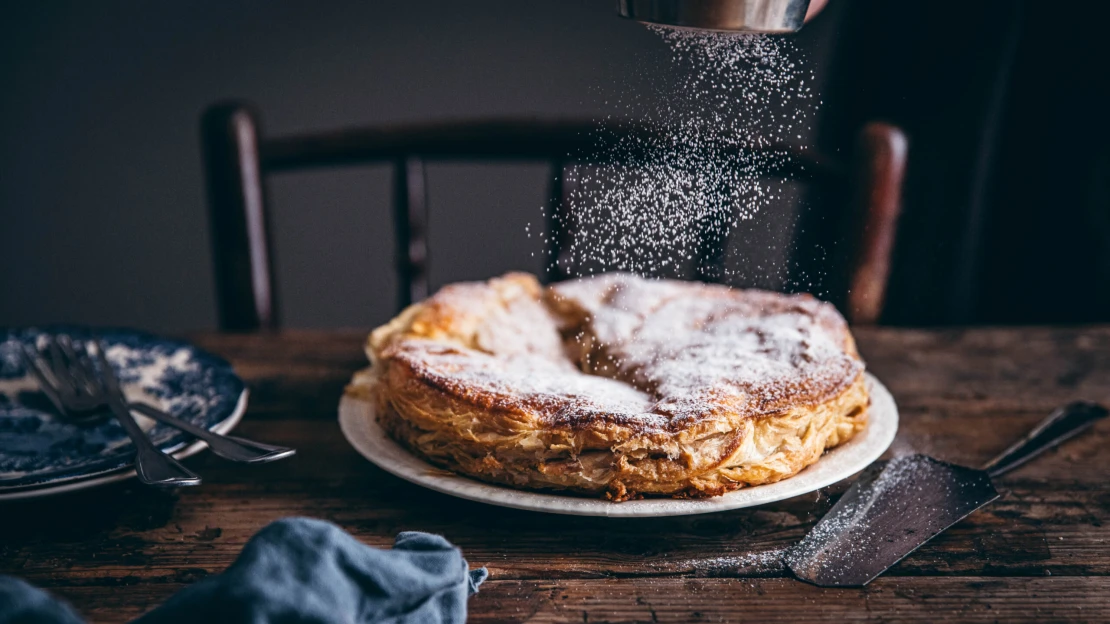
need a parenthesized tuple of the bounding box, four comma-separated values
(0, 517, 487, 624)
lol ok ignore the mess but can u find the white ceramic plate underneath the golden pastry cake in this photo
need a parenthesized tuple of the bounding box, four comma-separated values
(340, 374, 898, 517)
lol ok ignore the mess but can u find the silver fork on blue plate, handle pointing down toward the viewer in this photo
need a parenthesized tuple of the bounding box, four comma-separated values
(22, 336, 201, 487)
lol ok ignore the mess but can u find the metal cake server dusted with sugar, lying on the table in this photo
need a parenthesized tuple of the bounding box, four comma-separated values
(785, 402, 1108, 587)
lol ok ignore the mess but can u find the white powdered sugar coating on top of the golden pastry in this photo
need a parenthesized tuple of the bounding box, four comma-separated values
(391, 274, 862, 429)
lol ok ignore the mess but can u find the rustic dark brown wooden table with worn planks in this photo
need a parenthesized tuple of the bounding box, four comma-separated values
(0, 328, 1110, 622)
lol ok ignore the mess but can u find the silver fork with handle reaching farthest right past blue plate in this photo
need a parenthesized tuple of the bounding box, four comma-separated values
(21, 335, 296, 463)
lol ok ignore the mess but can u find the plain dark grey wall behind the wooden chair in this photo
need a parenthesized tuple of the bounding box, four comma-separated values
(0, 0, 834, 331)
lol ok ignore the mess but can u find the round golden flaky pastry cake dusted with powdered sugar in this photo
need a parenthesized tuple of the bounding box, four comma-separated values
(347, 273, 869, 501)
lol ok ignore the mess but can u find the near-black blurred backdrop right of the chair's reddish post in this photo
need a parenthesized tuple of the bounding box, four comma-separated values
(807, 0, 1110, 324)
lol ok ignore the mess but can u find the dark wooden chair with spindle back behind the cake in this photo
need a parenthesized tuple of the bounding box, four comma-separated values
(201, 102, 906, 331)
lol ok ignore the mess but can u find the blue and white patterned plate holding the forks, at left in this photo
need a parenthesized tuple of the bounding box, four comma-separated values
(0, 326, 246, 500)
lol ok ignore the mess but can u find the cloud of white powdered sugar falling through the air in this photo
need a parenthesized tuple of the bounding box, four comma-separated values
(529, 26, 816, 276)
